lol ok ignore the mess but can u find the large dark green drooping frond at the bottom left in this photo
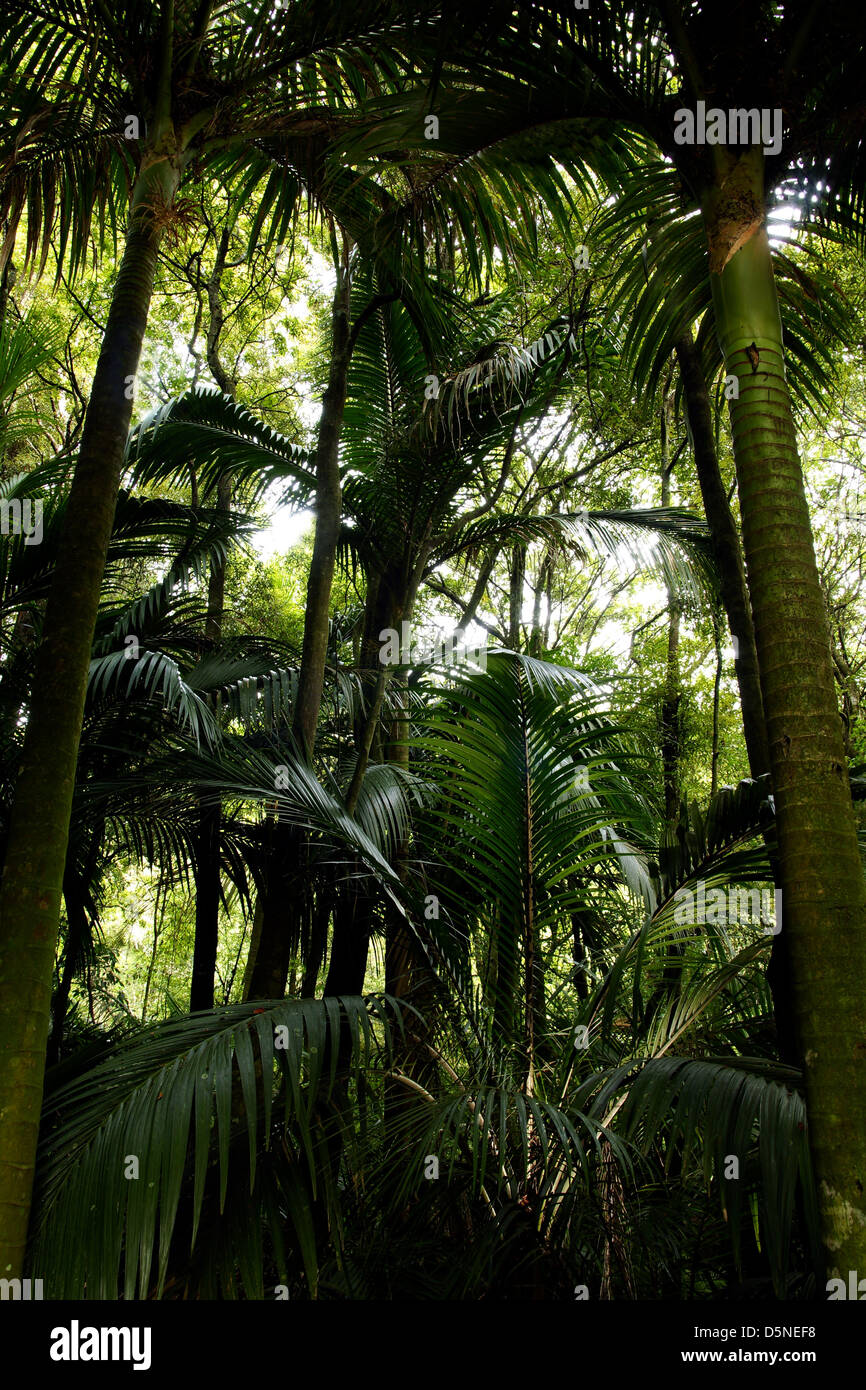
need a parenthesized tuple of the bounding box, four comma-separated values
(33, 998, 403, 1298)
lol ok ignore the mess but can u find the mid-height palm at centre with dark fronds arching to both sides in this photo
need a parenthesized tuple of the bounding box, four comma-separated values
(131, 296, 706, 997)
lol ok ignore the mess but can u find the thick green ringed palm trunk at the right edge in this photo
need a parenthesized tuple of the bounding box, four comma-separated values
(703, 152, 866, 1276)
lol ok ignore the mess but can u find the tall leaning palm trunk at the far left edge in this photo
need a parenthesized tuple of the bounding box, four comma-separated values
(0, 126, 179, 1277)
